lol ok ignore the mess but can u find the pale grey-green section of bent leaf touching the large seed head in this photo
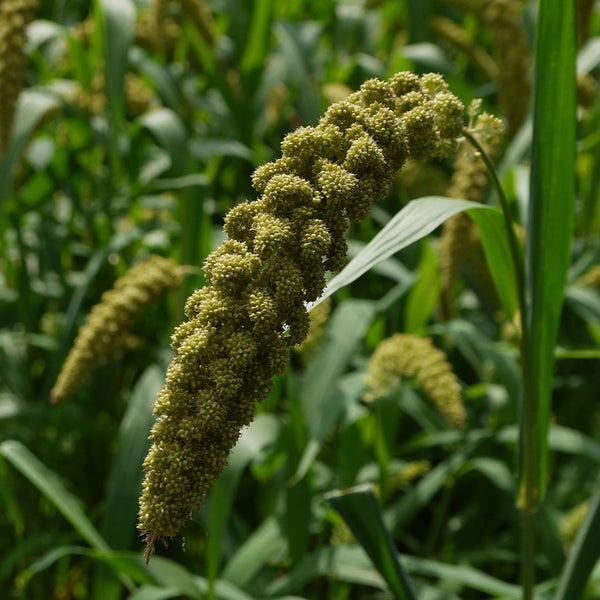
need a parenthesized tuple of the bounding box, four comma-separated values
(312, 196, 497, 306)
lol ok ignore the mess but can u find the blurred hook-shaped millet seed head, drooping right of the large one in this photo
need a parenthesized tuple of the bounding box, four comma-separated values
(365, 333, 465, 427)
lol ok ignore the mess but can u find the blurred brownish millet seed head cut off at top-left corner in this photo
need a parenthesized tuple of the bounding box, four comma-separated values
(0, 0, 37, 155)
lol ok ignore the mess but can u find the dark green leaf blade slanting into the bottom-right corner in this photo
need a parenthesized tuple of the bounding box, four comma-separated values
(554, 478, 600, 600)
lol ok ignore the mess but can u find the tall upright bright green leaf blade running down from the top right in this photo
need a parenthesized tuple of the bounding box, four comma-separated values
(521, 0, 576, 508)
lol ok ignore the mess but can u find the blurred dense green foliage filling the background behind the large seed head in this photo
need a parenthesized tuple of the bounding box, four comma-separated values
(0, 0, 600, 600)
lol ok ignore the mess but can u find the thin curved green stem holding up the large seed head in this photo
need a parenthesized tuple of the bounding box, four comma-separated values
(463, 129, 538, 600)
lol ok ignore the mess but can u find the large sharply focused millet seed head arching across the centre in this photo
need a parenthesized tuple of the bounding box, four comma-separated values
(138, 73, 463, 557)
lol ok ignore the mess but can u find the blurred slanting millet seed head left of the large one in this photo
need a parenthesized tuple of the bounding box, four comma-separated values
(50, 256, 184, 403)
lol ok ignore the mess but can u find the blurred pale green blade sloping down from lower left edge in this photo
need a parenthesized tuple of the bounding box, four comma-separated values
(0, 440, 108, 550)
